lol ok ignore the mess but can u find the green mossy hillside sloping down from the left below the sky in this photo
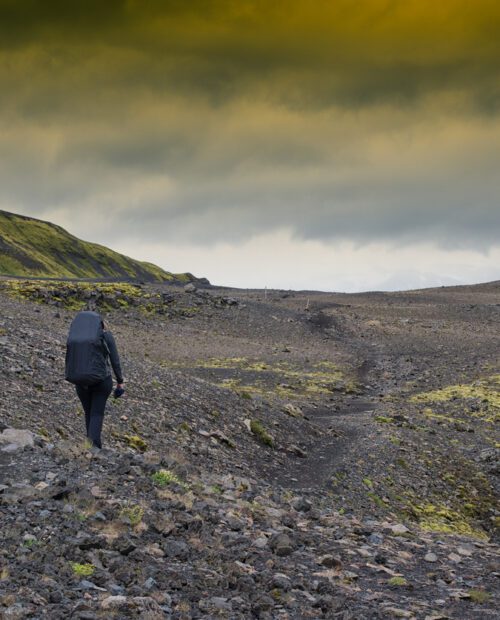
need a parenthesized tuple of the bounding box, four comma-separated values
(0, 210, 196, 282)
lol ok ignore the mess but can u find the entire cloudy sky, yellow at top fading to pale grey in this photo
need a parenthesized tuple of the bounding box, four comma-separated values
(0, 0, 500, 291)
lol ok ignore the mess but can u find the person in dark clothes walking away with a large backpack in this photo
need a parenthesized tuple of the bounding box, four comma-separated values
(66, 311, 124, 451)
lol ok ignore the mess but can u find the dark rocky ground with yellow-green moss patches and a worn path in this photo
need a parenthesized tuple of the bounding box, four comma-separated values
(0, 281, 500, 620)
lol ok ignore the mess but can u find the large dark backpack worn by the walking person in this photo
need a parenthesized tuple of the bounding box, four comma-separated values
(66, 312, 109, 386)
